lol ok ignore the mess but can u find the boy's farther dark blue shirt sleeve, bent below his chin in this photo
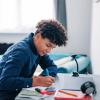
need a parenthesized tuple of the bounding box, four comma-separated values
(39, 55, 57, 77)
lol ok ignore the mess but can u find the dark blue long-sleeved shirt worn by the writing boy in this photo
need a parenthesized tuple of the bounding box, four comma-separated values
(0, 33, 57, 99)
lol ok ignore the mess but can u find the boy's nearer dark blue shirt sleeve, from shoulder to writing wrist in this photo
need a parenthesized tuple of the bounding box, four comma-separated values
(0, 50, 32, 90)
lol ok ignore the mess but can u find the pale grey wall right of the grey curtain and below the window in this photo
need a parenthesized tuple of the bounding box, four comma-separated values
(0, 0, 92, 55)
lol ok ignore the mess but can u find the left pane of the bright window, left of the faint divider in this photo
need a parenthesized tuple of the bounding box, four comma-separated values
(0, 0, 18, 32)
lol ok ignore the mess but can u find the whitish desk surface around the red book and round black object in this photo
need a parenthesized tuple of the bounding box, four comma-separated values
(15, 74, 100, 100)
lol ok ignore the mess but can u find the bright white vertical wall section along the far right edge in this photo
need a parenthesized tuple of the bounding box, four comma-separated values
(91, 0, 100, 74)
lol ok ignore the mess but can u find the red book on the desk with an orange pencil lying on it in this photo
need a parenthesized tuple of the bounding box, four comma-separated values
(54, 90, 92, 100)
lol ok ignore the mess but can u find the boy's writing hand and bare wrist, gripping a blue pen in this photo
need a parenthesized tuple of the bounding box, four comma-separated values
(32, 76, 55, 87)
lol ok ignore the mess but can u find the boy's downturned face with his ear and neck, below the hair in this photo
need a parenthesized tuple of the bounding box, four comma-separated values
(34, 33, 56, 56)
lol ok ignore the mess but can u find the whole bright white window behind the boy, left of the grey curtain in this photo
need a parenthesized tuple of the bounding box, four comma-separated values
(0, 0, 55, 33)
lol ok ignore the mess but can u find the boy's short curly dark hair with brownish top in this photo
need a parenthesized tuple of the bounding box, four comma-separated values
(35, 20, 68, 46)
